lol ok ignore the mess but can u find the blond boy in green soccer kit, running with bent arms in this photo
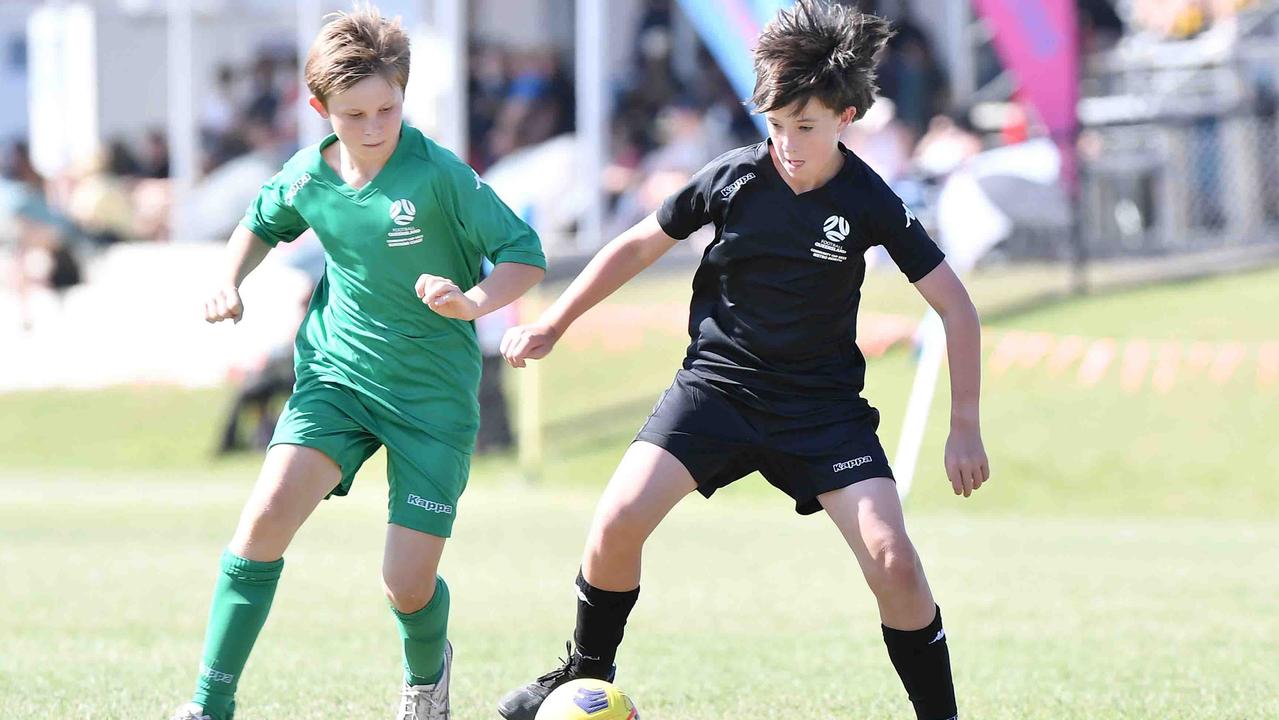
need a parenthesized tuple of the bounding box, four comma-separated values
(175, 8, 546, 720)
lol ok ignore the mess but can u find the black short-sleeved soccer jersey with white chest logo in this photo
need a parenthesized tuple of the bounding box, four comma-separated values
(657, 141, 944, 416)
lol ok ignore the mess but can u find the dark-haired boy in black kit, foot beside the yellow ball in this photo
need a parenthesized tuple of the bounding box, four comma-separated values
(498, 0, 990, 720)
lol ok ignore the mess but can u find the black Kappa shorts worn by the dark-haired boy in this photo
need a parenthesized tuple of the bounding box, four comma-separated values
(636, 370, 893, 515)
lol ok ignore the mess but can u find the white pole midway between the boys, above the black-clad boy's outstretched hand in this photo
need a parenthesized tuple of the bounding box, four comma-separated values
(576, 0, 609, 249)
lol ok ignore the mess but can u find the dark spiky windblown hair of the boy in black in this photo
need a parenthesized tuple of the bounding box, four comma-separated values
(751, 0, 893, 120)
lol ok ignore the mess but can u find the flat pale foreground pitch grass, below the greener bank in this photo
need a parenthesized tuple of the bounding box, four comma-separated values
(0, 474, 1279, 720)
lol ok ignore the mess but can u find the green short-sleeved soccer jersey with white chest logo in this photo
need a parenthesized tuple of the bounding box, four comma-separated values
(242, 124, 546, 451)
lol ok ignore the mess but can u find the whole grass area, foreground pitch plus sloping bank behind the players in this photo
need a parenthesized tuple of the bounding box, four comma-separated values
(0, 270, 1279, 720)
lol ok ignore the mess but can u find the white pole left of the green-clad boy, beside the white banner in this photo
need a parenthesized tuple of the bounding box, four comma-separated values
(166, 0, 196, 242)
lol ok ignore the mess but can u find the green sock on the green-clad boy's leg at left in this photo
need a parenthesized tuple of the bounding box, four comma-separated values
(192, 550, 284, 720)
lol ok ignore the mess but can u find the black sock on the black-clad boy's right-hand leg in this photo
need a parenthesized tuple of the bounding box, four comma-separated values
(881, 607, 959, 720)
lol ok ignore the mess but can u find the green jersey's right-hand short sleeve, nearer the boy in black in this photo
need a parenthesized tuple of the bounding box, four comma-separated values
(443, 160, 546, 270)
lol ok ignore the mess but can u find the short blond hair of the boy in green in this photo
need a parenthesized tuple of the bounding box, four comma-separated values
(304, 4, 409, 105)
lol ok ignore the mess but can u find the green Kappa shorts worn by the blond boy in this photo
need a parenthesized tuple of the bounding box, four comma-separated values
(271, 381, 471, 537)
